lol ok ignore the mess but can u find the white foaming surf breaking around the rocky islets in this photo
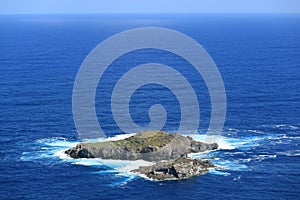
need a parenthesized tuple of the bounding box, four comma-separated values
(21, 126, 299, 185)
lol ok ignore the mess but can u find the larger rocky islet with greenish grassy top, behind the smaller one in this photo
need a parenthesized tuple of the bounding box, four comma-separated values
(65, 131, 218, 162)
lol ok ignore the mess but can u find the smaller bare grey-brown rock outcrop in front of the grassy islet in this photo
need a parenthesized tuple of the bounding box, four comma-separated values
(132, 158, 215, 180)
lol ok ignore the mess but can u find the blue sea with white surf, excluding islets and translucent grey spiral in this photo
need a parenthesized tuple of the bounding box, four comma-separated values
(0, 15, 300, 199)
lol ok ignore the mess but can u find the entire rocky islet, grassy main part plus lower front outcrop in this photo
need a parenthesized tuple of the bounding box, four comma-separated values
(65, 131, 218, 180)
